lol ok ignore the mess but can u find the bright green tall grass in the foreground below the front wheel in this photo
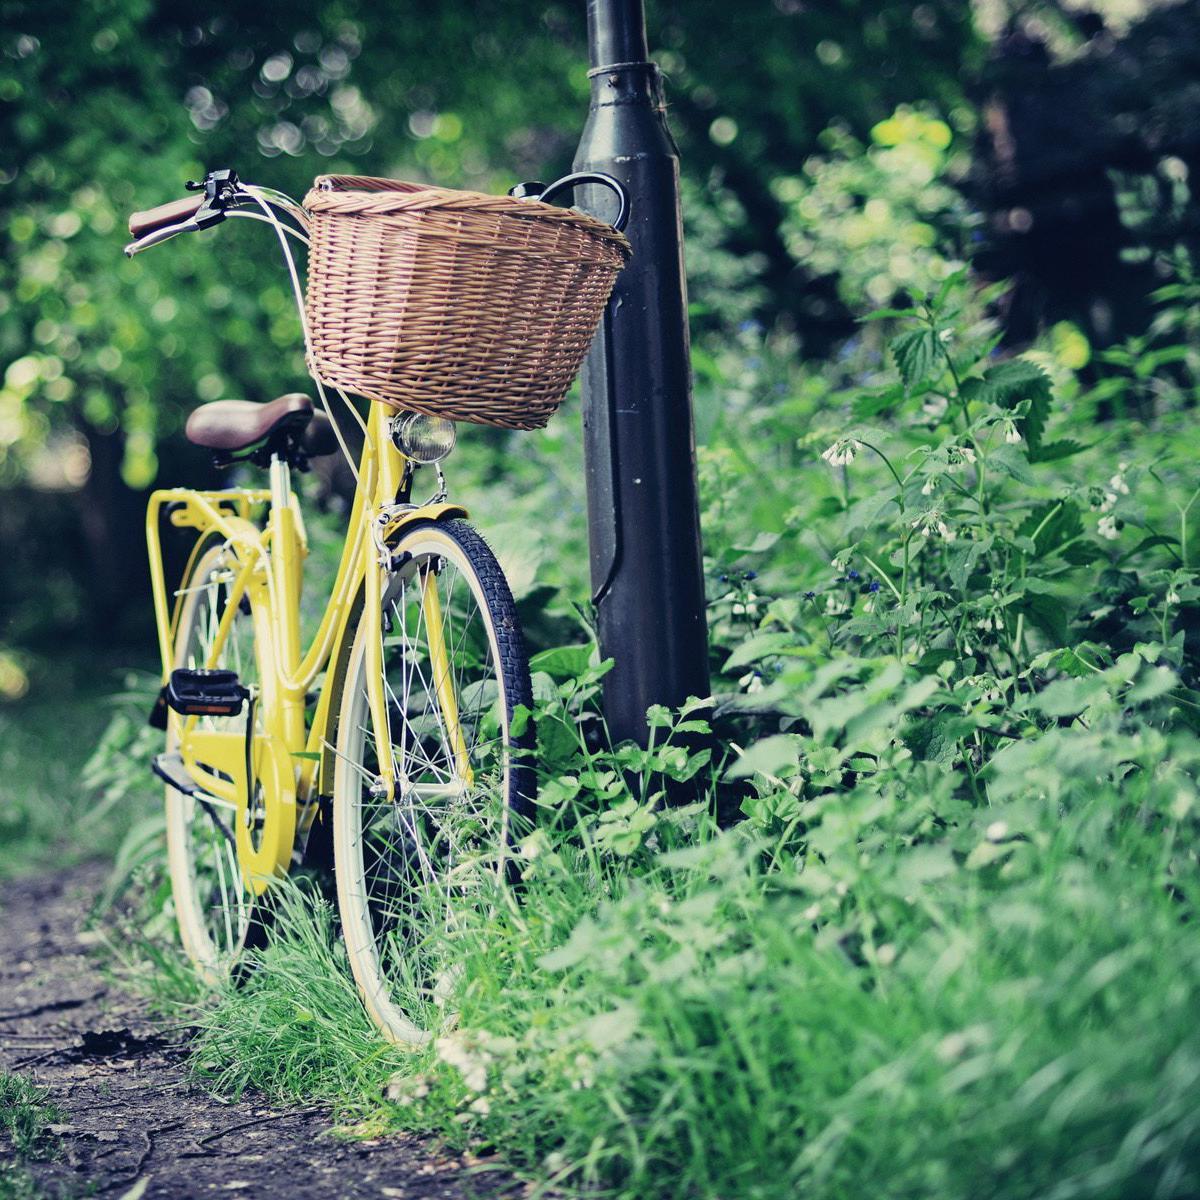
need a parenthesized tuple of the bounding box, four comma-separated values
(175, 720, 1200, 1200)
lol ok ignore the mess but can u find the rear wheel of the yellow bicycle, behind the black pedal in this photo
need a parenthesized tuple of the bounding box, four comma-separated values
(167, 542, 258, 986)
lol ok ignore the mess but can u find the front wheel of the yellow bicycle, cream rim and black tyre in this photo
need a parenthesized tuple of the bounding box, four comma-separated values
(334, 521, 535, 1044)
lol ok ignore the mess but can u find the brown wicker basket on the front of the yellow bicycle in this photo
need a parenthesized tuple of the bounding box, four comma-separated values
(304, 175, 630, 430)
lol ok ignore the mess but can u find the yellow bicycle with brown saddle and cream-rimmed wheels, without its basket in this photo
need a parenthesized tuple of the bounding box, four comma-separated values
(127, 172, 549, 1043)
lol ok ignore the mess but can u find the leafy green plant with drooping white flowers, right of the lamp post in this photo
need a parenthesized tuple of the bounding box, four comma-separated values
(724, 272, 1200, 833)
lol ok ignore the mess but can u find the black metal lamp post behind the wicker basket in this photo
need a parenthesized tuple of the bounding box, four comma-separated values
(575, 0, 709, 744)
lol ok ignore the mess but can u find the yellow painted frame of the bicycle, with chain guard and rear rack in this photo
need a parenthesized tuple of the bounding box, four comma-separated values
(146, 403, 467, 893)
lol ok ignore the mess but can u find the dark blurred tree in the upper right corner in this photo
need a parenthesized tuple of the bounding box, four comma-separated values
(967, 0, 1200, 346)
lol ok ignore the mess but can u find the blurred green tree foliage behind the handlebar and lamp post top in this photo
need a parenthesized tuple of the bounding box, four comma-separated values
(0, 0, 979, 638)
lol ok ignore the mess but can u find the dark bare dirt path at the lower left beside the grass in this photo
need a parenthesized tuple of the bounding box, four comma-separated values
(0, 866, 521, 1200)
